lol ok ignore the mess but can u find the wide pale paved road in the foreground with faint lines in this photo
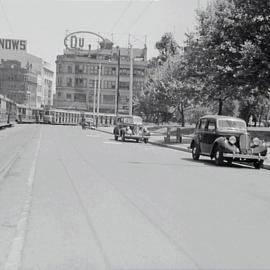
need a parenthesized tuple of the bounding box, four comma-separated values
(0, 125, 270, 270)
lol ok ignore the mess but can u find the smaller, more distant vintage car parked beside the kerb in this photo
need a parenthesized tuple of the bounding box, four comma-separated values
(113, 116, 150, 143)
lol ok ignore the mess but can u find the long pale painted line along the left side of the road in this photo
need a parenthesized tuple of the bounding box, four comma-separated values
(4, 127, 41, 270)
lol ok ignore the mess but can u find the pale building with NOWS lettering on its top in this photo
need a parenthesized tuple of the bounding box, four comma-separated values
(0, 38, 54, 108)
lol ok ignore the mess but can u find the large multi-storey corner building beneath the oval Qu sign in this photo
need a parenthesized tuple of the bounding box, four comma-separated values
(54, 32, 147, 114)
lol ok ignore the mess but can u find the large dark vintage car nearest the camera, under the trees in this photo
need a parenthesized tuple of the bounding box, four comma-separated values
(190, 115, 267, 169)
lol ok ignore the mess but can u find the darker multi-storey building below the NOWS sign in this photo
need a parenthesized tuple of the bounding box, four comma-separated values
(0, 60, 38, 107)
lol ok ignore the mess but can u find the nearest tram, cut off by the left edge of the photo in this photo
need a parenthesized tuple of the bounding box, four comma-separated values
(0, 95, 17, 127)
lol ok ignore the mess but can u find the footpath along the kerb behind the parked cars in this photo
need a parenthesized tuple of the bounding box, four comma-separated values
(96, 127, 270, 170)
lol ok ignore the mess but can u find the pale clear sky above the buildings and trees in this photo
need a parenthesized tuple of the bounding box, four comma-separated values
(0, 0, 208, 67)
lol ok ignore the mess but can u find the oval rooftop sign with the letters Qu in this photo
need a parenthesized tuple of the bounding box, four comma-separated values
(64, 31, 105, 50)
